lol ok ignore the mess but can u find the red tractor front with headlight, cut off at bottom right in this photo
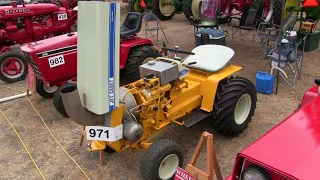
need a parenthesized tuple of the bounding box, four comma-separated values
(226, 79, 320, 180)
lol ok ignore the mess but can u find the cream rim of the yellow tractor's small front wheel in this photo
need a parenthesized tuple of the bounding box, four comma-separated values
(159, 154, 179, 179)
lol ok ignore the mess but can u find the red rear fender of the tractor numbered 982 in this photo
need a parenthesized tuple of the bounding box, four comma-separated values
(120, 38, 153, 69)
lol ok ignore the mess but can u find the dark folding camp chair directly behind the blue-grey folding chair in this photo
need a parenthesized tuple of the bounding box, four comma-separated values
(258, 12, 298, 49)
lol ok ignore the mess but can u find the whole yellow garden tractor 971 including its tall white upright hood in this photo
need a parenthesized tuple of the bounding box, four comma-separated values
(61, 1, 257, 180)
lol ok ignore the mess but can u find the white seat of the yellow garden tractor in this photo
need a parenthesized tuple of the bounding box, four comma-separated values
(183, 44, 234, 72)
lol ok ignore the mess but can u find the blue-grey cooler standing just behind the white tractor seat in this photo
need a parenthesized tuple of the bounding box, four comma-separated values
(196, 29, 226, 46)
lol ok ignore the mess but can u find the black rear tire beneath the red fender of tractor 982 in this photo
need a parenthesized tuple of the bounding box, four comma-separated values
(125, 46, 161, 83)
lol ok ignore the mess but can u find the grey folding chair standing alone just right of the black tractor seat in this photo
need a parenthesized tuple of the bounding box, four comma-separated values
(143, 13, 169, 42)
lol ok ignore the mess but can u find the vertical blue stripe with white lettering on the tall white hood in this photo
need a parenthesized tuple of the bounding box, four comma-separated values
(108, 3, 116, 111)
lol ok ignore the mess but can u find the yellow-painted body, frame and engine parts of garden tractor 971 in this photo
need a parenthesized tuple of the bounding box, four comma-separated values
(85, 61, 241, 152)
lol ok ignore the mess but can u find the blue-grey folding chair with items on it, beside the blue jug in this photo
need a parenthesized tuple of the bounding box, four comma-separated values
(266, 34, 308, 93)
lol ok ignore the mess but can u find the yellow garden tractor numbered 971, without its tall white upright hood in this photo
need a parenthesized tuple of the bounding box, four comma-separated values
(61, 45, 257, 180)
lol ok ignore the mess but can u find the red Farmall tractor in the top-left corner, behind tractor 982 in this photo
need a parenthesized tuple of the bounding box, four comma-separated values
(0, 1, 77, 83)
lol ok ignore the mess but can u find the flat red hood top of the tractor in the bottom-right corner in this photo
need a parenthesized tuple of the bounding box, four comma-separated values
(239, 96, 320, 180)
